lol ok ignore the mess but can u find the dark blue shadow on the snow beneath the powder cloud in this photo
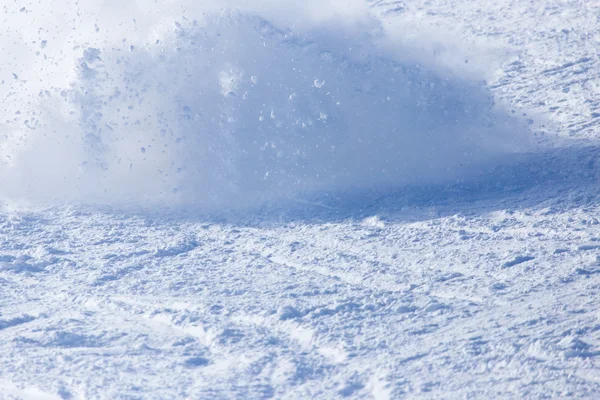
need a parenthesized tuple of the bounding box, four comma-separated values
(83, 141, 600, 227)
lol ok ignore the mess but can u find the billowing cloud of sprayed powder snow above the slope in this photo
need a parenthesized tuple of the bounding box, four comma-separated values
(0, 3, 525, 208)
